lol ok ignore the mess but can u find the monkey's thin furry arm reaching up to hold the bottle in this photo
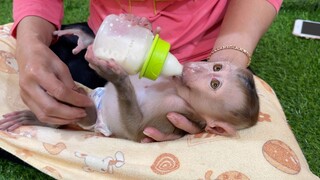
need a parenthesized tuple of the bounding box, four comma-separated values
(86, 54, 143, 140)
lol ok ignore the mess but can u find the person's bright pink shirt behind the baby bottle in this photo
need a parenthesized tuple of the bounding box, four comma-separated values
(13, 0, 282, 63)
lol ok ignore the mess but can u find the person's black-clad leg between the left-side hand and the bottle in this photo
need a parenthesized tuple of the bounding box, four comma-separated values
(50, 23, 106, 89)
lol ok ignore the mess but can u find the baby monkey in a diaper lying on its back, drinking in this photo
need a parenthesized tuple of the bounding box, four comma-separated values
(0, 29, 259, 142)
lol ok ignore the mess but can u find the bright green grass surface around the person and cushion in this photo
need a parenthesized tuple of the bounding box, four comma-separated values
(0, 0, 320, 179)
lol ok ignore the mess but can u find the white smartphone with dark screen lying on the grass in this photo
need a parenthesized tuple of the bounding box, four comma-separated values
(292, 19, 320, 39)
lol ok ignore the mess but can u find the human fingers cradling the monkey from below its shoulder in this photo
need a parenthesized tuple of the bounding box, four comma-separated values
(141, 112, 202, 143)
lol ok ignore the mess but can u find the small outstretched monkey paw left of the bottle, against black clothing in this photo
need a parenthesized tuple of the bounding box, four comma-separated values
(53, 29, 94, 54)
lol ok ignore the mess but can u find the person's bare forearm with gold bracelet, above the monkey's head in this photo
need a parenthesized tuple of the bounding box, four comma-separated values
(209, 0, 277, 68)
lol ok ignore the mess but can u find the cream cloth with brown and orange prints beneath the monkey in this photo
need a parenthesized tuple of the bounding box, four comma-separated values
(0, 24, 319, 180)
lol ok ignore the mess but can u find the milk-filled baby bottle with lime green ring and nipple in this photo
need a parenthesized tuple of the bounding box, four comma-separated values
(93, 14, 182, 80)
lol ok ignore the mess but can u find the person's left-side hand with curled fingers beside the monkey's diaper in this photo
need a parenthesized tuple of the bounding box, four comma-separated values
(16, 40, 92, 125)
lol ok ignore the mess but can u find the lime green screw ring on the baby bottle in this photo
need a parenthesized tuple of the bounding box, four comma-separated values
(139, 34, 170, 80)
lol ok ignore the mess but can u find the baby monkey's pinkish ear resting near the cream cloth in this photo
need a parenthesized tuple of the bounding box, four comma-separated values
(205, 121, 238, 137)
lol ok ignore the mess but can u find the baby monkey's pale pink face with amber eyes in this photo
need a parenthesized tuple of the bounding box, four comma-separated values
(174, 62, 244, 123)
